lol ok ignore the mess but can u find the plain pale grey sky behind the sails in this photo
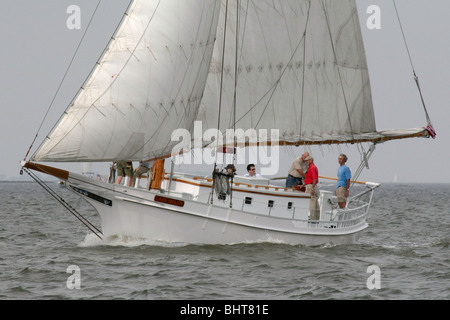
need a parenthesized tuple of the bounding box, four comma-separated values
(0, 0, 450, 183)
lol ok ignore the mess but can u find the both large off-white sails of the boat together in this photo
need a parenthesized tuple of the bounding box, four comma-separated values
(32, 0, 426, 161)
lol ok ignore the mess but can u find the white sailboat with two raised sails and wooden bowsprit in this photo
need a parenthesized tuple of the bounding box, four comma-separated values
(21, 0, 434, 245)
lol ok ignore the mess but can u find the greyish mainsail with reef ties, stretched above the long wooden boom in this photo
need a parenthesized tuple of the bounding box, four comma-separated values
(197, 0, 424, 145)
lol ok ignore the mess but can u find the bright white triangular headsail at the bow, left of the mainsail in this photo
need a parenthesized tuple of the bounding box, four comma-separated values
(32, 0, 220, 161)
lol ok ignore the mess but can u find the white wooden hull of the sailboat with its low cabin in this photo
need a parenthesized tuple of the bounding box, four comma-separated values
(67, 173, 373, 245)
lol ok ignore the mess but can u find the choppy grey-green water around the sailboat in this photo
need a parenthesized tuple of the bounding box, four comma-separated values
(0, 182, 450, 301)
